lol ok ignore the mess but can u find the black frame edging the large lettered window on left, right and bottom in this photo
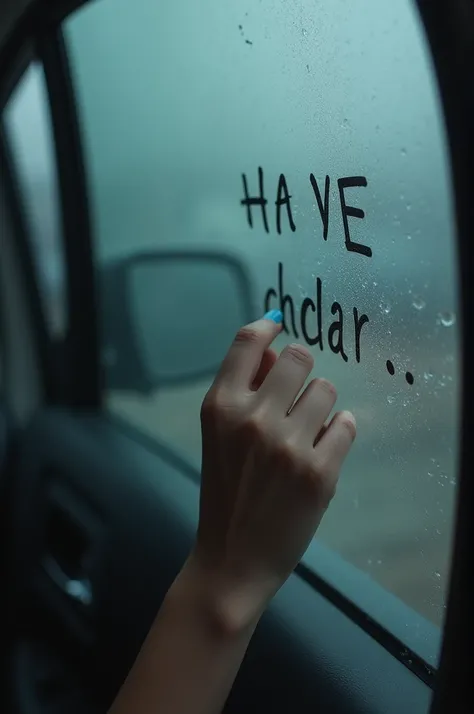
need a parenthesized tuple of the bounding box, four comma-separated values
(0, 0, 474, 714)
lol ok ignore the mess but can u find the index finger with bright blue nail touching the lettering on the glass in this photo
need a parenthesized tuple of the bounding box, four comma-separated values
(215, 310, 283, 389)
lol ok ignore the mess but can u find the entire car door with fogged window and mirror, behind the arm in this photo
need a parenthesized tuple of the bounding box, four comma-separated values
(1, 0, 472, 714)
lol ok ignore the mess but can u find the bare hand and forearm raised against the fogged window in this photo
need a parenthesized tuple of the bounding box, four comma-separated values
(109, 311, 356, 714)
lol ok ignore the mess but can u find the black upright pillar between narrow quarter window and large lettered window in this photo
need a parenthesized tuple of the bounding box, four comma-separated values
(37, 27, 102, 409)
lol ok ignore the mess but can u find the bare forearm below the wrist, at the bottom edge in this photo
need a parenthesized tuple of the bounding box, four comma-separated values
(109, 567, 258, 714)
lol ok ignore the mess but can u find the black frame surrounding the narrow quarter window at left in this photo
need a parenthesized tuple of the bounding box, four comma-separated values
(0, 0, 102, 410)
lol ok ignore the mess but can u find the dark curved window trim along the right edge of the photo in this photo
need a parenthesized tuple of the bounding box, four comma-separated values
(417, 0, 474, 714)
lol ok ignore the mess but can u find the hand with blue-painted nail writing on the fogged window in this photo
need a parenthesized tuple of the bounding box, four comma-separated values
(191, 310, 356, 628)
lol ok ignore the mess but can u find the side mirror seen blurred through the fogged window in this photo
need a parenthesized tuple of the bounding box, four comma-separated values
(98, 251, 253, 393)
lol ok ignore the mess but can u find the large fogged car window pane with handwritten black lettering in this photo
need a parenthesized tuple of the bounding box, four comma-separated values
(67, 0, 460, 624)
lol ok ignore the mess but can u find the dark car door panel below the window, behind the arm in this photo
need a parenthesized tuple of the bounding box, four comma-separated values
(4, 410, 430, 714)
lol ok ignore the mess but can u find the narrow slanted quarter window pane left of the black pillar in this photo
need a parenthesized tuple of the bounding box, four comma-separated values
(4, 63, 66, 338)
